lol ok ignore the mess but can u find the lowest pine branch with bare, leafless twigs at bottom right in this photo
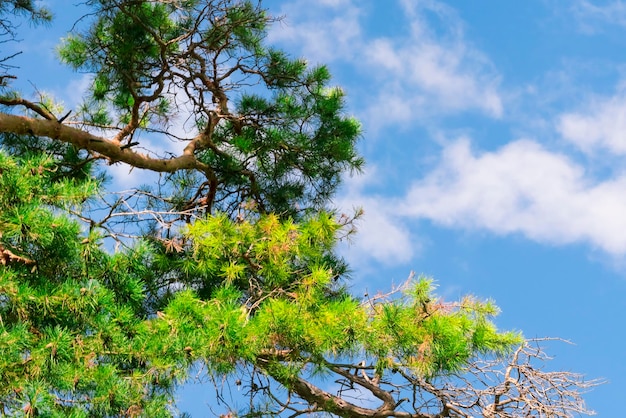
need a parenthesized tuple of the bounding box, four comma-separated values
(255, 339, 603, 418)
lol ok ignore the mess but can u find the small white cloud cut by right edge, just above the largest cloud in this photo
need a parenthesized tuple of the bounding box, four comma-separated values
(557, 91, 626, 155)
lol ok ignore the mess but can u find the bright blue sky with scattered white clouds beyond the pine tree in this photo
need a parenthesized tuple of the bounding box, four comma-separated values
(12, 0, 626, 416)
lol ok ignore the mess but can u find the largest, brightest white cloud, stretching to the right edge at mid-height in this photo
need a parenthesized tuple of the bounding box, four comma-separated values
(397, 139, 626, 255)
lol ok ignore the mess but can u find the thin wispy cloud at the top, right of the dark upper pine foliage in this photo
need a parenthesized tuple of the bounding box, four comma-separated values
(269, 0, 504, 132)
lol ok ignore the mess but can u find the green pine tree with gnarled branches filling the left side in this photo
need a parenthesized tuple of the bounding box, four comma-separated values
(0, 0, 596, 418)
